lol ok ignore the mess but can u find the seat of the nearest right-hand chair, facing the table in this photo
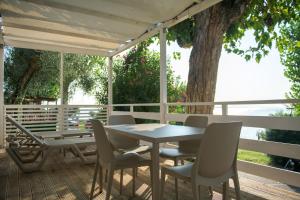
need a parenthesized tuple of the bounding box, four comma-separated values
(162, 163, 194, 181)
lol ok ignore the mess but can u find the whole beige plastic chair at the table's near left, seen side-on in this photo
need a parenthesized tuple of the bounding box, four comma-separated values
(90, 120, 152, 200)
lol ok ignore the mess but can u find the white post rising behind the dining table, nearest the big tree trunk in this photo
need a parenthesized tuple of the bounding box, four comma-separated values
(159, 28, 167, 123)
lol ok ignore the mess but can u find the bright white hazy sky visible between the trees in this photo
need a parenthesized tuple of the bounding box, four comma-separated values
(70, 31, 290, 104)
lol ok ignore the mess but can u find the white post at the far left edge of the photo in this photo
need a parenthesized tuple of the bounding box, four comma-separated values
(0, 44, 5, 149)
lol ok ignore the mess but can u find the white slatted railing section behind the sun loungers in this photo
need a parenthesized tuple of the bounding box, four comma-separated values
(2, 105, 107, 142)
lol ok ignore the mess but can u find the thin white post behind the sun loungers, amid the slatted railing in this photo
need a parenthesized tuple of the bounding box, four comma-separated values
(58, 52, 65, 131)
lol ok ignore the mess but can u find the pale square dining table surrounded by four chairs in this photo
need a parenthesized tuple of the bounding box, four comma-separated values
(105, 124, 205, 200)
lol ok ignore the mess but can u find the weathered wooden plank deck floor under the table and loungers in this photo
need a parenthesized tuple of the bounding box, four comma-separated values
(0, 153, 300, 200)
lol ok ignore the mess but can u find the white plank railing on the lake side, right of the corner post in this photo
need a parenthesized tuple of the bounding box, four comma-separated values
(112, 100, 300, 187)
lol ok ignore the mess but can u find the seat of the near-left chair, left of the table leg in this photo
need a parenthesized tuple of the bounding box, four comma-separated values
(115, 152, 151, 169)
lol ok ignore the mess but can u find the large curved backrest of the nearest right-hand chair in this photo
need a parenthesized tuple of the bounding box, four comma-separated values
(194, 122, 242, 178)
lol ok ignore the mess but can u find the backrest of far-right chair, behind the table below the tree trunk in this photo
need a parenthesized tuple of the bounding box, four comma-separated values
(178, 115, 208, 154)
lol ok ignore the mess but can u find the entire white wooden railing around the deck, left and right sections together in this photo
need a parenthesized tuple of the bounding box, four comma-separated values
(2, 100, 300, 187)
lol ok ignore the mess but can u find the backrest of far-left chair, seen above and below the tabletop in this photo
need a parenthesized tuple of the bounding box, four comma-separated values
(108, 115, 140, 149)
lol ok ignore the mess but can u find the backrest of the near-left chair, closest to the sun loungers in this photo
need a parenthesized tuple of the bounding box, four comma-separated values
(91, 119, 115, 166)
